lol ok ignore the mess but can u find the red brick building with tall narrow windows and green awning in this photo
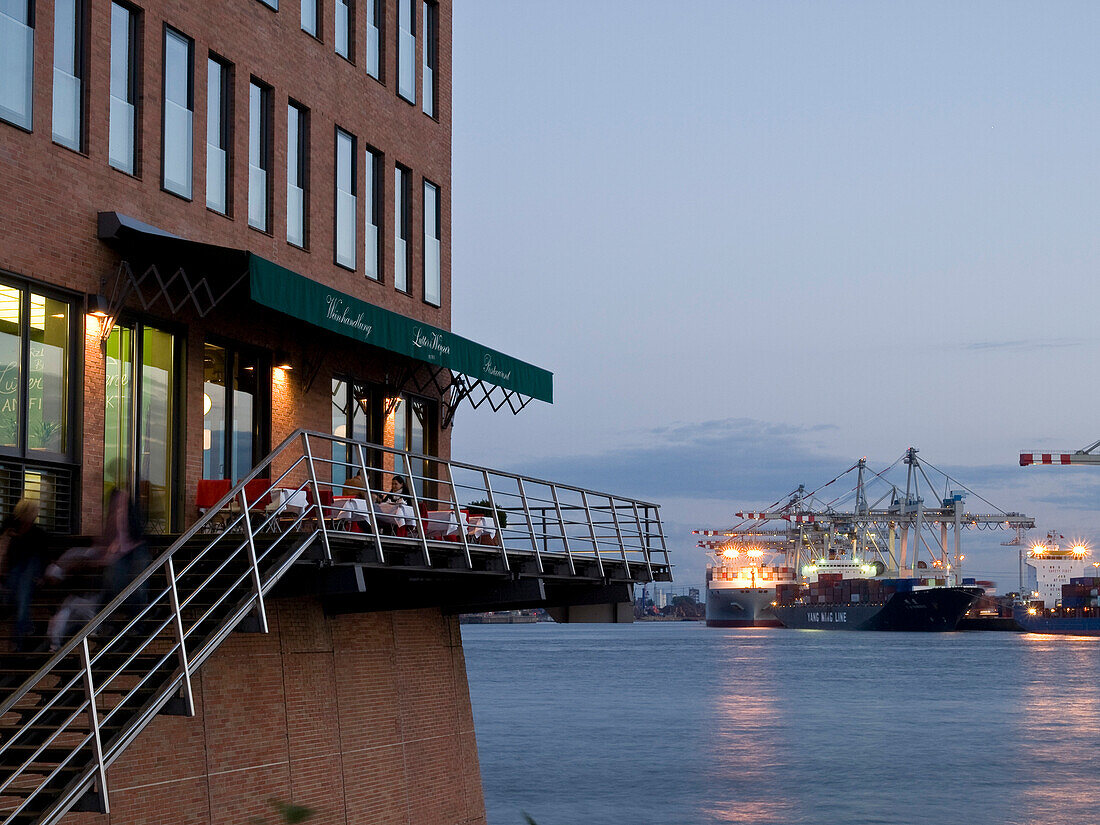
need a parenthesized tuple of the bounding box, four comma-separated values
(0, 0, 567, 824)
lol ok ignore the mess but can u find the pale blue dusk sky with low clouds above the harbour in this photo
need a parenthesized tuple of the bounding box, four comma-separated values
(452, 0, 1100, 591)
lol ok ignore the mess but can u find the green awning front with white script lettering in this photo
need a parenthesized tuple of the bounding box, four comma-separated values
(249, 253, 553, 404)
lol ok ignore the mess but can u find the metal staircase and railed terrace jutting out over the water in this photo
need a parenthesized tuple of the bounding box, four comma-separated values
(0, 430, 671, 825)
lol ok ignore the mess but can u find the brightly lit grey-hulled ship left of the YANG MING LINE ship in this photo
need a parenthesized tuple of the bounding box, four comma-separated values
(706, 541, 798, 627)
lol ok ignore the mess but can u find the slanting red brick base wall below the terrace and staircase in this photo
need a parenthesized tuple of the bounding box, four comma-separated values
(63, 600, 485, 825)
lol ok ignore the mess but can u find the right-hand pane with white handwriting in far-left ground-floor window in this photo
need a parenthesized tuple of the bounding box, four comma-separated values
(26, 295, 69, 452)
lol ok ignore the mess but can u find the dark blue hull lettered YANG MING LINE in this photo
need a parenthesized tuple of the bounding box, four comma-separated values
(773, 587, 982, 633)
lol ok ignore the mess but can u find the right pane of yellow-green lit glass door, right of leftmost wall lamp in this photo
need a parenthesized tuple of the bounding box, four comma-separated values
(138, 327, 175, 530)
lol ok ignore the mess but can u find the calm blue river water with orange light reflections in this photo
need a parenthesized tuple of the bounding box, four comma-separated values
(462, 623, 1100, 825)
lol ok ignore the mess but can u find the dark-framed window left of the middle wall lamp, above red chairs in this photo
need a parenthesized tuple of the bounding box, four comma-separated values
(202, 342, 271, 482)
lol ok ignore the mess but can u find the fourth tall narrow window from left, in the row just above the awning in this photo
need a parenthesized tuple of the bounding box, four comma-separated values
(162, 29, 195, 198)
